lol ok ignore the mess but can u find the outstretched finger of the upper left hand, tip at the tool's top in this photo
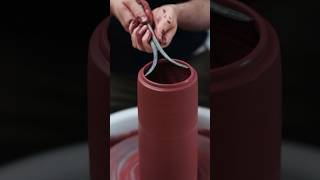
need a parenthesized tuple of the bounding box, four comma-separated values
(123, 0, 148, 23)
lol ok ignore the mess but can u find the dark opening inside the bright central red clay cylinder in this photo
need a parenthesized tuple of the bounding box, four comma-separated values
(144, 60, 191, 84)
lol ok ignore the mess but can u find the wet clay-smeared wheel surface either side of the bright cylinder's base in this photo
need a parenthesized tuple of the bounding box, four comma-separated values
(110, 134, 210, 180)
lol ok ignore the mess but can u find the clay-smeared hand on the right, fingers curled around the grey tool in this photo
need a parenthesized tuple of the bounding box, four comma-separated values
(129, 5, 177, 53)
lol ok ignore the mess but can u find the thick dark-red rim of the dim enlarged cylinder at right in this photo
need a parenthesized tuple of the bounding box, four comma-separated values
(211, 0, 280, 92)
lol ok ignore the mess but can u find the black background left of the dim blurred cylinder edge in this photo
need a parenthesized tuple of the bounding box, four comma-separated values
(0, 0, 109, 164)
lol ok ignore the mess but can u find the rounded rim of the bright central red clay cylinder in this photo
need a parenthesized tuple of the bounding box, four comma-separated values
(138, 59, 197, 91)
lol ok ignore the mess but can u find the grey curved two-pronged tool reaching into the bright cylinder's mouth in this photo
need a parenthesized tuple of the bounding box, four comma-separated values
(145, 24, 189, 76)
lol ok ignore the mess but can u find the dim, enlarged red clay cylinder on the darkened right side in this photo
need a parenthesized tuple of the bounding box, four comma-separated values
(211, 0, 281, 180)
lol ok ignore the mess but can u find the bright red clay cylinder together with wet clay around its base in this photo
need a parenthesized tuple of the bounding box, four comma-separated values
(110, 60, 210, 180)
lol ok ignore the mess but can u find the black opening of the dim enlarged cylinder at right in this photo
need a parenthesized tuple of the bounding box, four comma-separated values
(212, 10, 259, 68)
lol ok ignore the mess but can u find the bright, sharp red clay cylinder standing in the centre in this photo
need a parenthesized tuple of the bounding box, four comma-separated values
(138, 61, 198, 180)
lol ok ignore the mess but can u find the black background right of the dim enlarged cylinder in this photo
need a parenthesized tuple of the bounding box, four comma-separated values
(242, 0, 320, 146)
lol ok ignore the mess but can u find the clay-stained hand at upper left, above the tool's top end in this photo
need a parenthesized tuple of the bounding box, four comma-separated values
(110, 0, 152, 32)
